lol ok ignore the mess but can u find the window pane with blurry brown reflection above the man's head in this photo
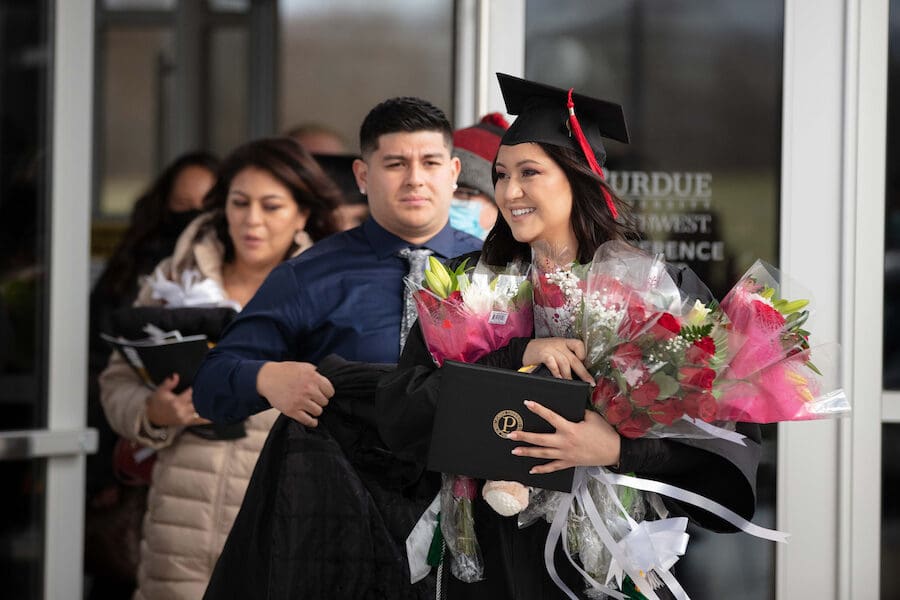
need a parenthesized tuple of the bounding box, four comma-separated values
(278, 0, 454, 151)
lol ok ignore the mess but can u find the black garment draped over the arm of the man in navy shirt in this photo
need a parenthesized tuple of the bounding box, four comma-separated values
(203, 357, 439, 600)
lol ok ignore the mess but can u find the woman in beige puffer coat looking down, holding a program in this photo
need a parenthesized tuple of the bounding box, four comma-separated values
(100, 138, 340, 600)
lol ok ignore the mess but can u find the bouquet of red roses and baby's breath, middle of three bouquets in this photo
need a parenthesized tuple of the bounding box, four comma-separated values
(582, 242, 733, 438)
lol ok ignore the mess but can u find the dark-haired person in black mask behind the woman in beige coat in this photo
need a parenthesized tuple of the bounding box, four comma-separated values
(85, 152, 219, 599)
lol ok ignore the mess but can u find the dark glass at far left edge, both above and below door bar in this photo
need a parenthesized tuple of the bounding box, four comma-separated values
(0, 0, 52, 598)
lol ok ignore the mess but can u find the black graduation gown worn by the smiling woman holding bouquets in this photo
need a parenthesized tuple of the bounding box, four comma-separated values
(376, 255, 760, 600)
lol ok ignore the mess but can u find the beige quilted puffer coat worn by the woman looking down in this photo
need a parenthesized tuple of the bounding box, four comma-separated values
(100, 215, 311, 600)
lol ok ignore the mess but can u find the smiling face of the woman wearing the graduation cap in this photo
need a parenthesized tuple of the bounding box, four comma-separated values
(495, 142, 578, 253)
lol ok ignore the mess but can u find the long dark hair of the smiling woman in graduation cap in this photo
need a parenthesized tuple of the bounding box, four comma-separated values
(481, 142, 640, 265)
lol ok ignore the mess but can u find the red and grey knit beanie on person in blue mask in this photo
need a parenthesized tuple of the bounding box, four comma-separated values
(453, 112, 509, 200)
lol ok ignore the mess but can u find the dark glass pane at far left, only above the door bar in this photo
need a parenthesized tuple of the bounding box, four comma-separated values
(0, 2, 50, 429)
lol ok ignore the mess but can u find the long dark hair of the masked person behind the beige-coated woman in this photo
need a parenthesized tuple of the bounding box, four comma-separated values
(97, 152, 219, 303)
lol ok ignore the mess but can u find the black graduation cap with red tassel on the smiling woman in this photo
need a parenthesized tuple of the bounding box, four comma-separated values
(497, 73, 628, 165)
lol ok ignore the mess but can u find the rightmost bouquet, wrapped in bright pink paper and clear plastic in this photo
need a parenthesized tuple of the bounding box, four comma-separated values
(715, 260, 850, 423)
